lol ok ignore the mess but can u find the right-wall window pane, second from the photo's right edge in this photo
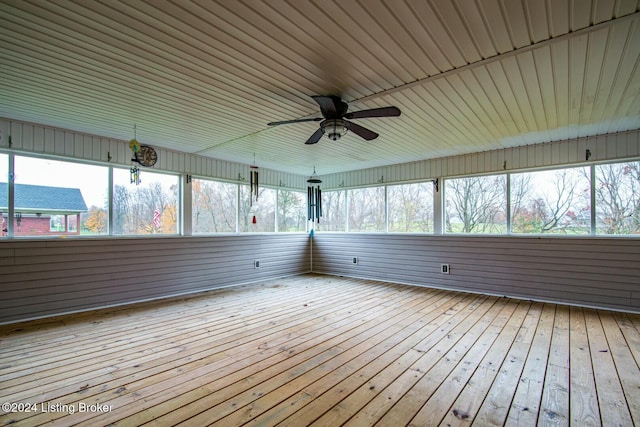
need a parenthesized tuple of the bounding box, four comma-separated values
(510, 167, 591, 234)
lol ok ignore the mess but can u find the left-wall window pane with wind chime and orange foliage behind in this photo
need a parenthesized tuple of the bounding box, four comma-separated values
(113, 168, 179, 235)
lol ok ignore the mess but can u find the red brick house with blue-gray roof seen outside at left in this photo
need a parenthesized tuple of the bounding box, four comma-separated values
(0, 182, 87, 236)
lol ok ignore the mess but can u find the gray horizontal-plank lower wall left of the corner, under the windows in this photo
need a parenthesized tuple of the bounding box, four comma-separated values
(0, 233, 310, 323)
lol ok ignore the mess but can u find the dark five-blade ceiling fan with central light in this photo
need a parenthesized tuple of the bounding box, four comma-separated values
(267, 95, 400, 144)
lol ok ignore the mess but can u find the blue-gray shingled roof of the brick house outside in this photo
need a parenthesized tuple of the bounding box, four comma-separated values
(0, 182, 87, 213)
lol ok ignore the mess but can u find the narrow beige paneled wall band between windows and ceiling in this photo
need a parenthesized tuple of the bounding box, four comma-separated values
(0, 119, 640, 190)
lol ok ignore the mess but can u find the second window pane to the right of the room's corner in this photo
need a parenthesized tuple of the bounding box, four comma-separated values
(349, 187, 384, 231)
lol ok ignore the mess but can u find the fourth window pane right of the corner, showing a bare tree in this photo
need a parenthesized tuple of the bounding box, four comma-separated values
(444, 175, 507, 233)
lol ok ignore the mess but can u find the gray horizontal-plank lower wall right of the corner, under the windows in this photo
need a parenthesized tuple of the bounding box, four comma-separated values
(312, 233, 640, 312)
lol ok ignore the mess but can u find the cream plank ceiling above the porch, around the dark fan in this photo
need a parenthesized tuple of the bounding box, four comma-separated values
(0, 0, 640, 175)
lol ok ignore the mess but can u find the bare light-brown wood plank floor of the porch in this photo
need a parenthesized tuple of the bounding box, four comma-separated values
(0, 275, 640, 426)
